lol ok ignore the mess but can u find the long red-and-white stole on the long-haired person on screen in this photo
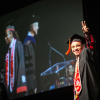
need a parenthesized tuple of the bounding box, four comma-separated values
(5, 39, 16, 92)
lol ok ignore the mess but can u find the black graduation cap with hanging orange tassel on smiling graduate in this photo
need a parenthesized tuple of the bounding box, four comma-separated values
(65, 33, 86, 55)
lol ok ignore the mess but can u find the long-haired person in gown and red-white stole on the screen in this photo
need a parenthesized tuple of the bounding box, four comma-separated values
(5, 25, 27, 99)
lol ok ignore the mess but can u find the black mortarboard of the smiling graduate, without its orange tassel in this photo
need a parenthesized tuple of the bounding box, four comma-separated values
(67, 33, 86, 44)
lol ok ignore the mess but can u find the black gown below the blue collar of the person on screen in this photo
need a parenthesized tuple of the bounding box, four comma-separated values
(24, 40, 36, 95)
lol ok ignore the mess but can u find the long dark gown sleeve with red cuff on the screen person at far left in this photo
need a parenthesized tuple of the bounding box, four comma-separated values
(15, 41, 27, 93)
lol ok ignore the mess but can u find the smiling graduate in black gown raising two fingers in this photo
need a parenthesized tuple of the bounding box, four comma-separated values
(65, 21, 100, 100)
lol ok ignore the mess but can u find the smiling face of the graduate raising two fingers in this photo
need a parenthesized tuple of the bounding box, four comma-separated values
(71, 41, 84, 57)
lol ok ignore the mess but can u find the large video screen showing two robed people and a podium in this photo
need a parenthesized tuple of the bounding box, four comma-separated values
(0, 0, 83, 99)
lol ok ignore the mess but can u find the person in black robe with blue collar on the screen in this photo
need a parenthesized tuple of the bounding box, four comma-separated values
(23, 22, 39, 95)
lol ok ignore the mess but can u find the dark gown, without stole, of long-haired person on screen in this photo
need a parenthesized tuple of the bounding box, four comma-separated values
(4, 40, 27, 99)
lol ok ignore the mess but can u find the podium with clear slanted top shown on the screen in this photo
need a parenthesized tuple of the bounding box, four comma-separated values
(40, 60, 74, 92)
